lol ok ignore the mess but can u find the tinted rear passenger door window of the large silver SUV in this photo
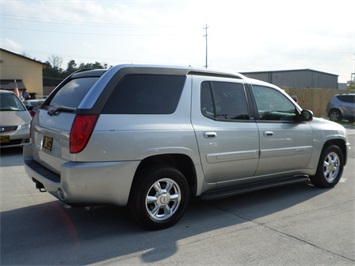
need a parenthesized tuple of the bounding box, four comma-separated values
(201, 81, 249, 120)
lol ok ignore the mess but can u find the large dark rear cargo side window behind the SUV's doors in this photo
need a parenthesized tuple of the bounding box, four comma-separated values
(103, 74, 186, 114)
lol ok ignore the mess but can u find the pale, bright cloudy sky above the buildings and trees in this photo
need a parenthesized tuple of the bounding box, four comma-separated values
(0, 0, 355, 82)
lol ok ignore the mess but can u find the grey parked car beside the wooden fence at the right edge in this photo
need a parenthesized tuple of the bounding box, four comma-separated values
(326, 93, 355, 121)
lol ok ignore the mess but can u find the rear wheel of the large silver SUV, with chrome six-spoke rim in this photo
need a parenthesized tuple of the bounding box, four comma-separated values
(129, 166, 190, 230)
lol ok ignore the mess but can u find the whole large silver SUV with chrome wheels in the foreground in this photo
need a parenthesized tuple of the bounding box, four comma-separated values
(24, 65, 349, 229)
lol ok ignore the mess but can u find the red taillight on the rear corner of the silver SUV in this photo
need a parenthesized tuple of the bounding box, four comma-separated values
(69, 115, 99, 153)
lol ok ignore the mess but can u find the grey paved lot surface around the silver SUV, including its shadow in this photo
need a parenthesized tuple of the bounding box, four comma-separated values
(0, 129, 355, 265)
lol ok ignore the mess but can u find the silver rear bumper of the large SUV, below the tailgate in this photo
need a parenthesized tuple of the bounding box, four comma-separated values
(24, 145, 139, 206)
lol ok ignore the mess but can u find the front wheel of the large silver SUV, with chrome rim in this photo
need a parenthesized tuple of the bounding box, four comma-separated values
(310, 145, 344, 188)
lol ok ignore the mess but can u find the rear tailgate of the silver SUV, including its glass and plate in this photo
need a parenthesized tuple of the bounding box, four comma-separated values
(32, 76, 100, 166)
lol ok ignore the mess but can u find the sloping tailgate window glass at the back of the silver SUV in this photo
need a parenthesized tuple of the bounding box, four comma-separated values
(49, 77, 98, 108)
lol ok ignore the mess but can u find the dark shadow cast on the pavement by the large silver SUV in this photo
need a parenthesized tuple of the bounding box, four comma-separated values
(1, 183, 326, 265)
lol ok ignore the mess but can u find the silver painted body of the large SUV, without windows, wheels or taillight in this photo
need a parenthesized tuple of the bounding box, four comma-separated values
(24, 65, 347, 206)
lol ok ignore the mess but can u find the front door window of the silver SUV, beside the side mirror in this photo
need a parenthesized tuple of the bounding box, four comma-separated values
(253, 85, 297, 121)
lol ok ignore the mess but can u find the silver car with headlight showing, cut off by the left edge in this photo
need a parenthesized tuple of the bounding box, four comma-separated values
(0, 90, 31, 148)
